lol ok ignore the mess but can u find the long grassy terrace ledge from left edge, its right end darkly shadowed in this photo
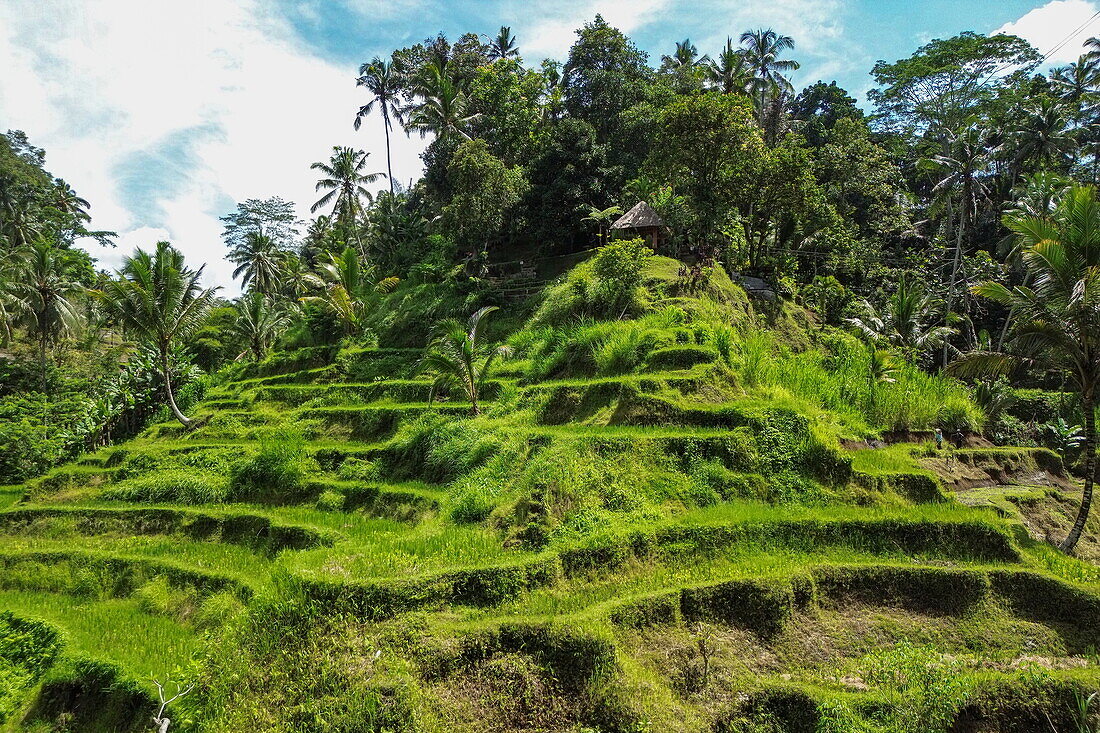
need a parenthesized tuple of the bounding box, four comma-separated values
(0, 505, 337, 555)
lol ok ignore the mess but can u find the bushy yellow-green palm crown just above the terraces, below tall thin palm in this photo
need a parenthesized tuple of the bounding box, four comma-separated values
(303, 247, 398, 335)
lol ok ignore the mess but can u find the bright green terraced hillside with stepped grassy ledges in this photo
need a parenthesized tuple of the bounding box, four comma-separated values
(0, 259, 1100, 731)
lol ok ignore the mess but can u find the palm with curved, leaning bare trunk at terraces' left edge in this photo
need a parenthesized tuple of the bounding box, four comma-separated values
(99, 242, 218, 427)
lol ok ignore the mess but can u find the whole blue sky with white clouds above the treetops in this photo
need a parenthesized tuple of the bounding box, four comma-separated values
(0, 0, 1100, 294)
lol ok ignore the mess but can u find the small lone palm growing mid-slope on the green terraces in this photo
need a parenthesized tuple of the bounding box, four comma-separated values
(420, 306, 512, 415)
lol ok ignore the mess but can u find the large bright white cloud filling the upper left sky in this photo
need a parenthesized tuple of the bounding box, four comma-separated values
(0, 0, 424, 293)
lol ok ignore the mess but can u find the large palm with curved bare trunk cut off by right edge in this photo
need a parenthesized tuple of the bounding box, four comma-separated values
(950, 186, 1100, 553)
